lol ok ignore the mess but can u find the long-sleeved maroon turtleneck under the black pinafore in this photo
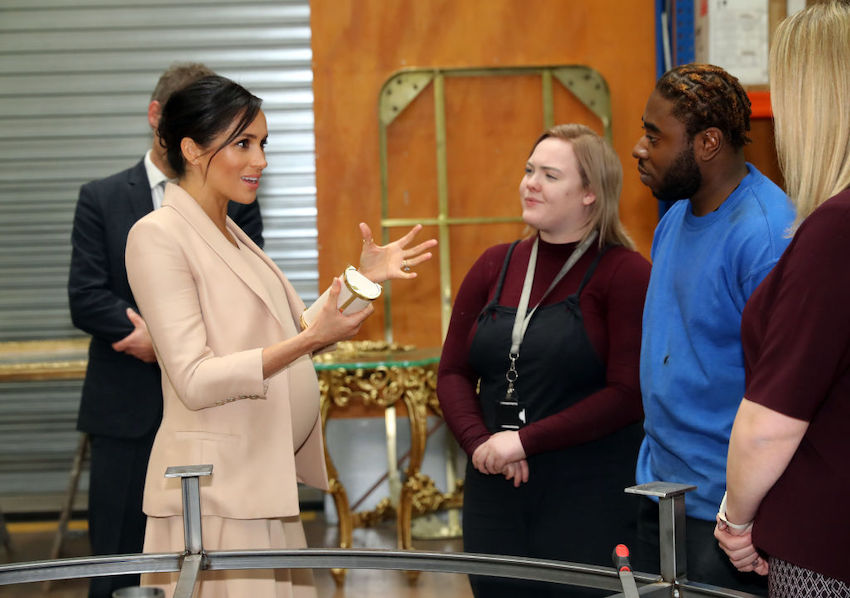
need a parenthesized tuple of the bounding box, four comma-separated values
(437, 238, 650, 456)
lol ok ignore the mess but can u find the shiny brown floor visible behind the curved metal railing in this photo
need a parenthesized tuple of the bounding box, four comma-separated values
(0, 512, 472, 598)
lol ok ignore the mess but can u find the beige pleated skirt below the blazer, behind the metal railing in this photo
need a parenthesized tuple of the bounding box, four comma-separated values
(142, 516, 316, 598)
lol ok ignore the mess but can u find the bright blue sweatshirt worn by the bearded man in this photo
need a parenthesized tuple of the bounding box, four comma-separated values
(636, 164, 794, 521)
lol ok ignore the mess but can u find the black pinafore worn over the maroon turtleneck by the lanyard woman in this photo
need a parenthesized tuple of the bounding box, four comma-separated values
(463, 243, 643, 598)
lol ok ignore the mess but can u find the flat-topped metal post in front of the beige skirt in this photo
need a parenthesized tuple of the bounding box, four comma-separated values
(165, 465, 212, 598)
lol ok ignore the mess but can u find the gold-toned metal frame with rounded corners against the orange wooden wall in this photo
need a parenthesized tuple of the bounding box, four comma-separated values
(378, 65, 612, 342)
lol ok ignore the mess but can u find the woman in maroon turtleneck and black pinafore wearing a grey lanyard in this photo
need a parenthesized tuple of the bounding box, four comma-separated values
(437, 124, 650, 598)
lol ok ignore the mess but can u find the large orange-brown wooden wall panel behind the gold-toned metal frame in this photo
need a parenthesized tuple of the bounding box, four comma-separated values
(311, 0, 657, 346)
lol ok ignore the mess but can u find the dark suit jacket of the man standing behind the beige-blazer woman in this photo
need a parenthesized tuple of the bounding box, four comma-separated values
(68, 160, 263, 438)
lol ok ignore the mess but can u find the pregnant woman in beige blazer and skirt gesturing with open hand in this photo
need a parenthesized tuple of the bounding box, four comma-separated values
(126, 76, 436, 598)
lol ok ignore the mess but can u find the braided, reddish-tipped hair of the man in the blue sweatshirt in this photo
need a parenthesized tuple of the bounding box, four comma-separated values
(655, 64, 751, 149)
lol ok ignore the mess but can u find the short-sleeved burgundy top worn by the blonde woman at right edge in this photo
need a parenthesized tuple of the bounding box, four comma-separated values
(741, 190, 850, 584)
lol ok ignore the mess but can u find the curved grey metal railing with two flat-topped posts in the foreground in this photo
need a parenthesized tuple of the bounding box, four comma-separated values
(0, 465, 755, 598)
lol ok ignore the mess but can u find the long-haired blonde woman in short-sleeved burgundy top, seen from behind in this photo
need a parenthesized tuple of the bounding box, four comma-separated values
(715, 1, 850, 597)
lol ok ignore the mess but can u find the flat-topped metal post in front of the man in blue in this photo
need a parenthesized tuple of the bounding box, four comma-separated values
(625, 482, 696, 584)
